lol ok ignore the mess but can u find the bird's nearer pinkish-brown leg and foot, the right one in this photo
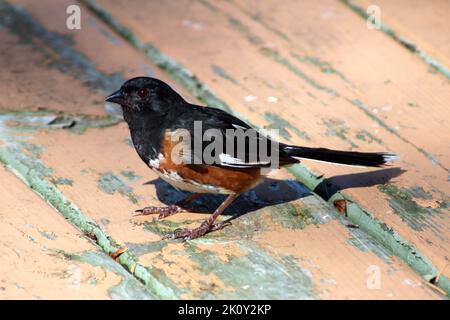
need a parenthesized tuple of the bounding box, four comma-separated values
(164, 193, 239, 240)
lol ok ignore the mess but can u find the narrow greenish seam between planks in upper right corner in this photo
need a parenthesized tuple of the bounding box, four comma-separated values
(341, 0, 450, 79)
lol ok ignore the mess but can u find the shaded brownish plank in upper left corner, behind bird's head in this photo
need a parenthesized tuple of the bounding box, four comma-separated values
(0, 1, 193, 116)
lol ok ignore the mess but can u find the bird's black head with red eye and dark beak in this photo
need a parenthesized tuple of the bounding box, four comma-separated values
(105, 77, 184, 113)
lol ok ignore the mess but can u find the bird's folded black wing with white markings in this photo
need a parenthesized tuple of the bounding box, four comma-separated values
(171, 105, 298, 169)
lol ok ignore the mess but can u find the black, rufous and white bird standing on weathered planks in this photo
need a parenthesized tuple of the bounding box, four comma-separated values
(105, 77, 398, 240)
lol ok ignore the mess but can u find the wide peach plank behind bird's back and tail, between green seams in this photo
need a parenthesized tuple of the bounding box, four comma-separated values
(87, 1, 450, 284)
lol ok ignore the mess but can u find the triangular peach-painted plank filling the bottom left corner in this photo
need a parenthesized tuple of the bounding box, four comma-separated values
(0, 167, 150, 300)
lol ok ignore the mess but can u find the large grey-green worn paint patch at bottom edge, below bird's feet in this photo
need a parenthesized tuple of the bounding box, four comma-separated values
(186, 240, 317, 299)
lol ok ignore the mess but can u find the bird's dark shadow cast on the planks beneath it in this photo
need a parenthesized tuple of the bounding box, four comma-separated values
(145, 168, 405, 218)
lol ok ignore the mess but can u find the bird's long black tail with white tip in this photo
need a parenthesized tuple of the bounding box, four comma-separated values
(284, 146, 398, 167)
